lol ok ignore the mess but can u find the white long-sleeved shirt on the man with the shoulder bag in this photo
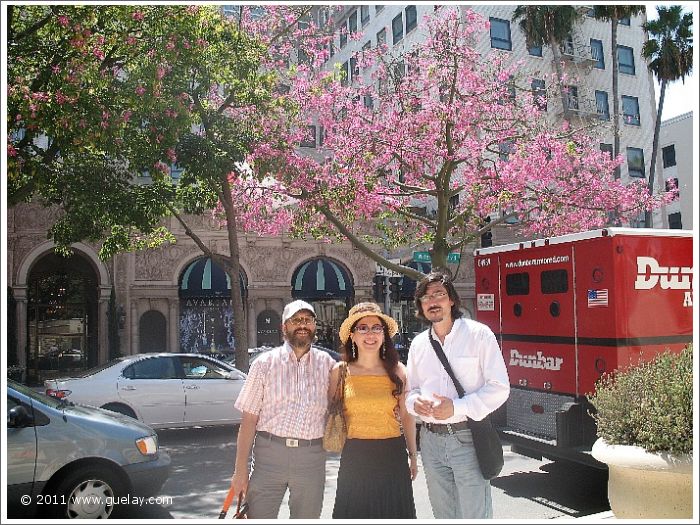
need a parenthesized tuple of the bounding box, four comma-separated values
(406, 318, 510, 423)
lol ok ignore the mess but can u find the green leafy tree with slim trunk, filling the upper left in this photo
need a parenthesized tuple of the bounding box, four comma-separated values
(7, 5, 290, 369)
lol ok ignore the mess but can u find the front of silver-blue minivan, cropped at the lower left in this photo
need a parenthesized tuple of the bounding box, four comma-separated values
(7, 379, 170, 519)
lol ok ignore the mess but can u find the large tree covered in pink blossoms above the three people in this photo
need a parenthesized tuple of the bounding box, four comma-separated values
(233, 7, 669, 278)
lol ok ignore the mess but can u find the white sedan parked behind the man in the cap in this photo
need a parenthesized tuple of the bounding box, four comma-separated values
(44, 353, 246, 428)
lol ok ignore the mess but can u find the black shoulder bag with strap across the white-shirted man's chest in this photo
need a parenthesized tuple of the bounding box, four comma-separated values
(428, 329, 503, 479)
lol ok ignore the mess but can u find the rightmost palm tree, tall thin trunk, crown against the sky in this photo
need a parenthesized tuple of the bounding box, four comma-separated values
(642, 5, 693, 228)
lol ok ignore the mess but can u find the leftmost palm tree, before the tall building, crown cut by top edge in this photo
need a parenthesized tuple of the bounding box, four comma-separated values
(512, 5, 581, 123)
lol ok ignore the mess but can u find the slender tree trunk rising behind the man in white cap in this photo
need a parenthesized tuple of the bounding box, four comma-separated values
(221, 174, 248, 372)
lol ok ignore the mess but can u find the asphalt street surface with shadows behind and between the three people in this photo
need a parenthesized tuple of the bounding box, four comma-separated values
(119, 427, 610, 521)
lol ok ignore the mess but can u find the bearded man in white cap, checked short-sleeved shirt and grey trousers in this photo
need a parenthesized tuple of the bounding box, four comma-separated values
(231, 301, 335, 519)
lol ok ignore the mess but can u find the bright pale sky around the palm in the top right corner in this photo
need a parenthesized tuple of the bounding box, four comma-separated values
(644, 2, 700, 121)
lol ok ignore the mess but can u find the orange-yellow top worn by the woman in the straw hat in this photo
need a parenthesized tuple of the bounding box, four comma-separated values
(345, 373, 401, 439)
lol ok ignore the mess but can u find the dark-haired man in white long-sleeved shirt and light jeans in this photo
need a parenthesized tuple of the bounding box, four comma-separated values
(406, 272, 510, 519)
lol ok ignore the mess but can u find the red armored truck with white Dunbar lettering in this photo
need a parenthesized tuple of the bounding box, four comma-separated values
(474, 228, 693, 467)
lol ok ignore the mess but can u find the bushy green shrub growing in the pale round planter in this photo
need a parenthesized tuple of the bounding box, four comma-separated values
(589, 345, 693, 454)
